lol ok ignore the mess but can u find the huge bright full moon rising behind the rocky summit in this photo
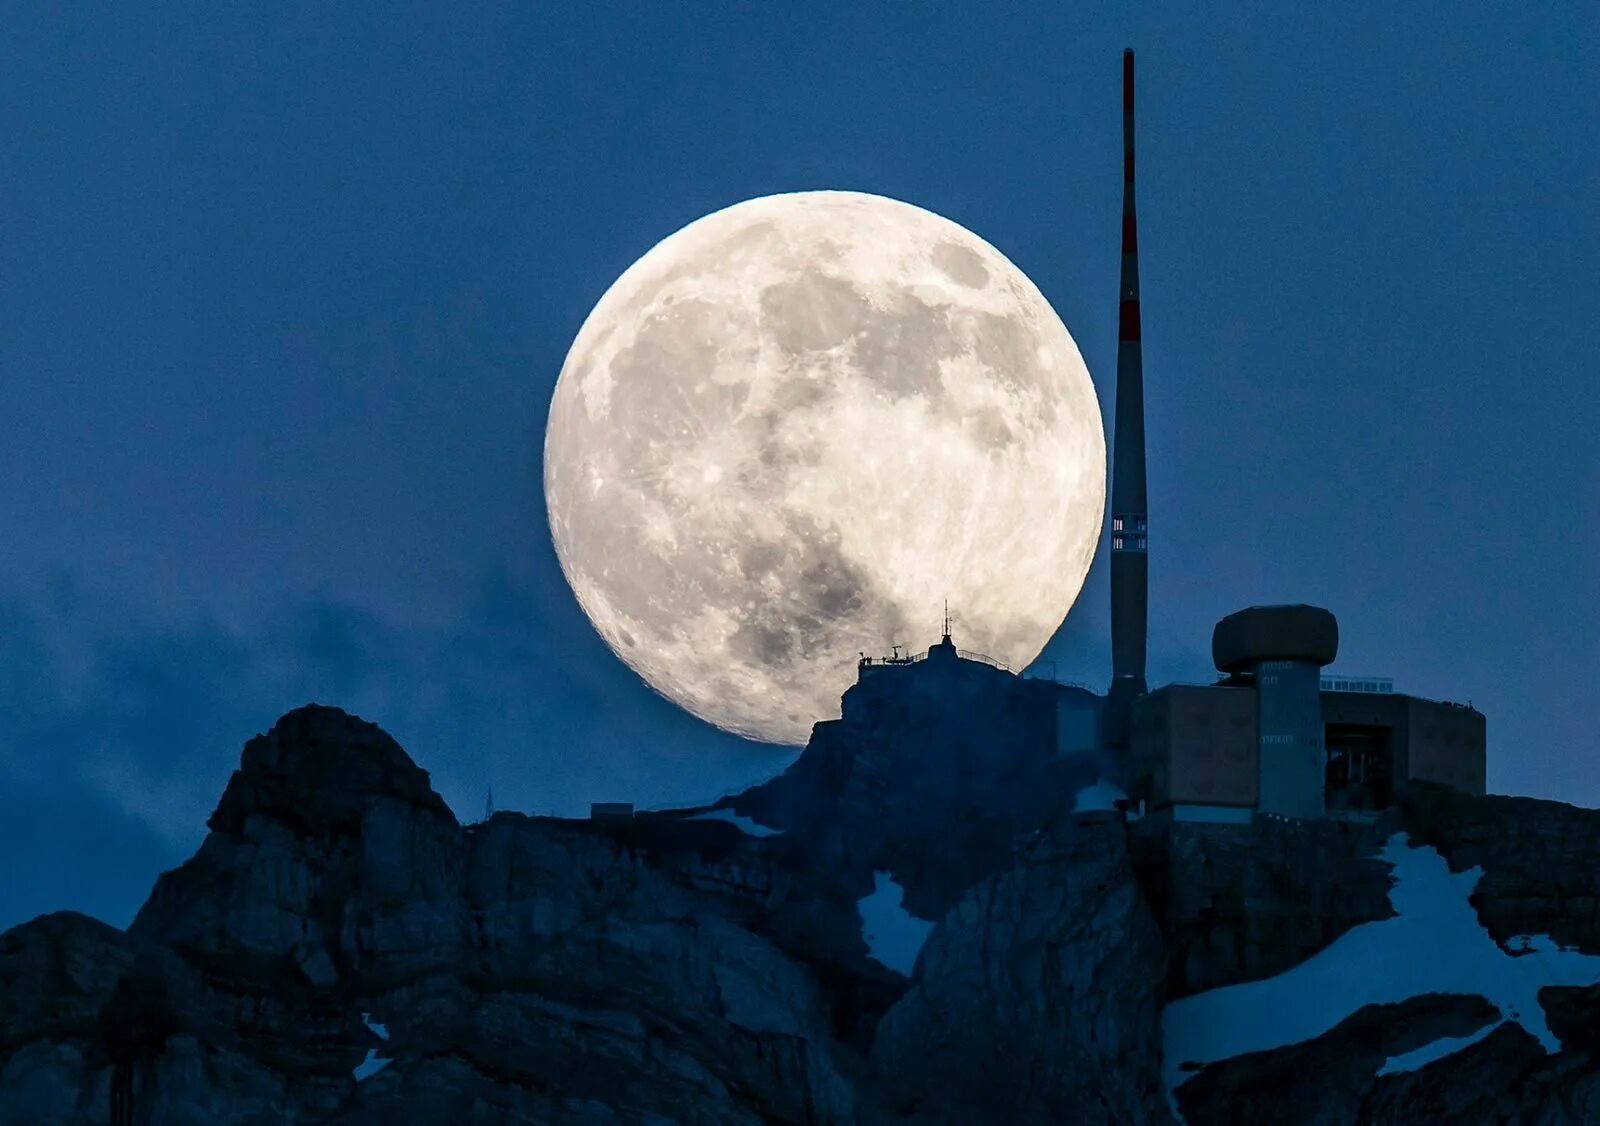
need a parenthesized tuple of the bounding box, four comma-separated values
(544, 192, 1106, 744)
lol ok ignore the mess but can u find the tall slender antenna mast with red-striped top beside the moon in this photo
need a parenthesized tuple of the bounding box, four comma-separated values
(1106, 51, 1150, 745)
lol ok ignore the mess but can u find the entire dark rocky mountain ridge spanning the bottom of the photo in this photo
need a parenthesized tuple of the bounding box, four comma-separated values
(0, 690, 1600, 1126)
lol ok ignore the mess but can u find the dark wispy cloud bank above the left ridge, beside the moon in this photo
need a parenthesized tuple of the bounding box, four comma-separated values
(0, 574, 790, 926)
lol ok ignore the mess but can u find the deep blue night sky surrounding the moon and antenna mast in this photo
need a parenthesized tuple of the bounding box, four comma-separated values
(0, 0, 1600, 926)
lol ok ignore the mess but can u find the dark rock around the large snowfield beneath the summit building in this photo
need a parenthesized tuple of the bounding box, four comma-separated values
(1152, 787, 1600, 1126)
